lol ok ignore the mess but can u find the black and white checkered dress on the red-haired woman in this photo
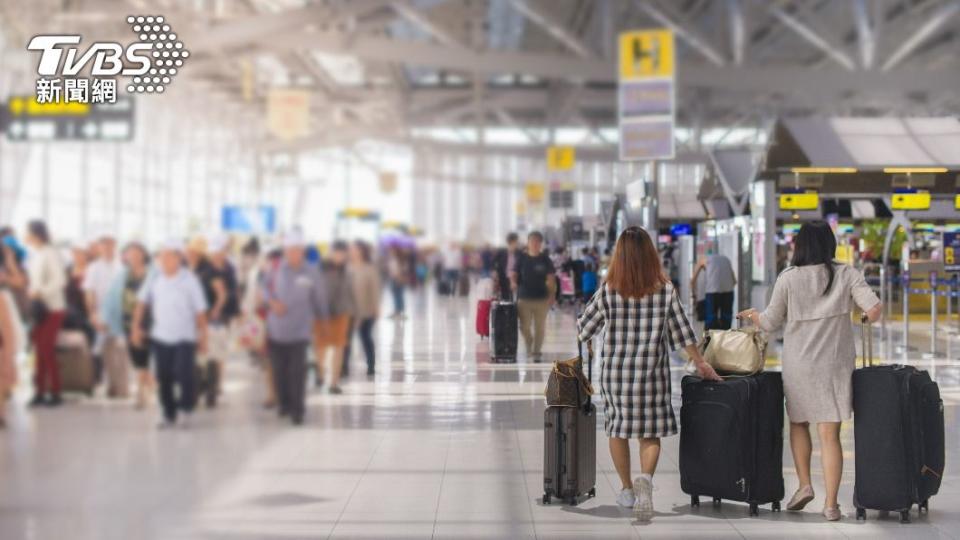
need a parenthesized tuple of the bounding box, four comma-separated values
(578, 283, 697, 439)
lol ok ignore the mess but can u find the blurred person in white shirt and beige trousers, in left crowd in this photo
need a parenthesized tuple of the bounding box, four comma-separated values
(81, 233, 129, 398)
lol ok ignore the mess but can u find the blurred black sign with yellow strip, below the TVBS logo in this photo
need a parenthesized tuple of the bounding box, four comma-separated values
(0, 96, 135, 141)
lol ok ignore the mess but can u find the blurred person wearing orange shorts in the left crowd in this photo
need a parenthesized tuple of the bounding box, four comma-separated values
(314, 240, 356, 394)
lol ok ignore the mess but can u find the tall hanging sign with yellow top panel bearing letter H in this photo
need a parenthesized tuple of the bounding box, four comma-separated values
(617, 29, 676, 161)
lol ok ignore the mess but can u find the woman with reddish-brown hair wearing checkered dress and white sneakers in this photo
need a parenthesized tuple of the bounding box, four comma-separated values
(578, 227, 719, 519)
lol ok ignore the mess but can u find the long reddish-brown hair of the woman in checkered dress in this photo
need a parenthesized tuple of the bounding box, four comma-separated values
(607, 227, 668, 298)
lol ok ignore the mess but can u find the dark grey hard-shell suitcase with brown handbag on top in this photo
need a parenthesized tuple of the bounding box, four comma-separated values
(543, 402, 597, 506)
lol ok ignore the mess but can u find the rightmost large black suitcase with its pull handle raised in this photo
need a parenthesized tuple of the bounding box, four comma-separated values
(853, 316, 946, 523)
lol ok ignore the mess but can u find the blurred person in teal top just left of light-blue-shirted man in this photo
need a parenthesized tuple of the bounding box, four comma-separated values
(100, 242, 155, 409)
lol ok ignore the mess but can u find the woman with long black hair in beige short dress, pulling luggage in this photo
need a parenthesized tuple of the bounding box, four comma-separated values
(737, 220, 882, 521)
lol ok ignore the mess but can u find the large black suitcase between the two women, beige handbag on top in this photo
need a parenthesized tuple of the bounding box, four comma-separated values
(680, 372, 783, 516)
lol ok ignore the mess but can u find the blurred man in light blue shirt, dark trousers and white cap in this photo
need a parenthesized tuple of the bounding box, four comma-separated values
(131, 240, 207, 429)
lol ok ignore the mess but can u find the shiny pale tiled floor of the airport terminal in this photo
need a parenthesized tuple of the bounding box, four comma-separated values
(0, 297, 960, 540)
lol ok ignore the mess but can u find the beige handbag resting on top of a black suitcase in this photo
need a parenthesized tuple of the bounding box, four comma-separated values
(700, 328, 767, 375)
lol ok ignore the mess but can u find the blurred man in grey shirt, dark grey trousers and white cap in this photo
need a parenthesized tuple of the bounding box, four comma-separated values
(262, 231, 328, 425)
